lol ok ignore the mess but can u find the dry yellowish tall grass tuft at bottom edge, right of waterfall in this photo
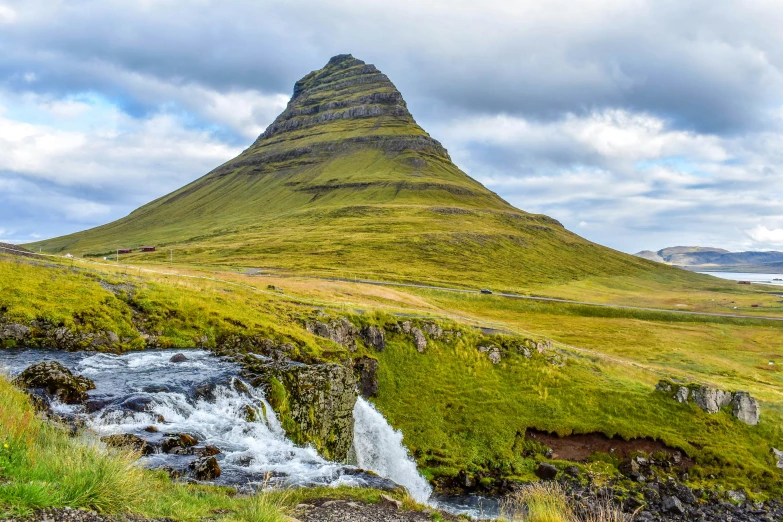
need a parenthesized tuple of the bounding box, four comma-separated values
(501, 482, 633, 522)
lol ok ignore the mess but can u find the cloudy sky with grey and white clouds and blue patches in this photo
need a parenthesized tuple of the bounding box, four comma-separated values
(0, 0, 783, 252)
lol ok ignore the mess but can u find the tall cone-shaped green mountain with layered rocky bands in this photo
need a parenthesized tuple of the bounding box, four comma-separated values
(33, 55, 673, 288)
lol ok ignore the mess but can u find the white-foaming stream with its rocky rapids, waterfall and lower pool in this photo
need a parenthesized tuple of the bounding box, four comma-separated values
(0, 350, 498, 518)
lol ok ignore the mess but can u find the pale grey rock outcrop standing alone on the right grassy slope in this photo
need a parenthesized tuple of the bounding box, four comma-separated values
(655, 380, 761, 426)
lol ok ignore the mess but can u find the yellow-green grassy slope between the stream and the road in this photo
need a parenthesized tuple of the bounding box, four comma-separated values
(0, 254, 783, 495)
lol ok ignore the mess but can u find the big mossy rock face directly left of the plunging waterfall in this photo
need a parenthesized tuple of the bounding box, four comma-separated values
(262, 363, 357, 461)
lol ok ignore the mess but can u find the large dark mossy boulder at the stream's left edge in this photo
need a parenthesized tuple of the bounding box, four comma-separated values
(13, 361, 95, 404)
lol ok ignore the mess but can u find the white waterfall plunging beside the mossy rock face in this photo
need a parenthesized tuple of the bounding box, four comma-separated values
(353, 397, 432, 503)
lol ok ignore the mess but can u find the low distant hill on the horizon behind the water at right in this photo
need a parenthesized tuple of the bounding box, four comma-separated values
(634, 247, 783, 273)
